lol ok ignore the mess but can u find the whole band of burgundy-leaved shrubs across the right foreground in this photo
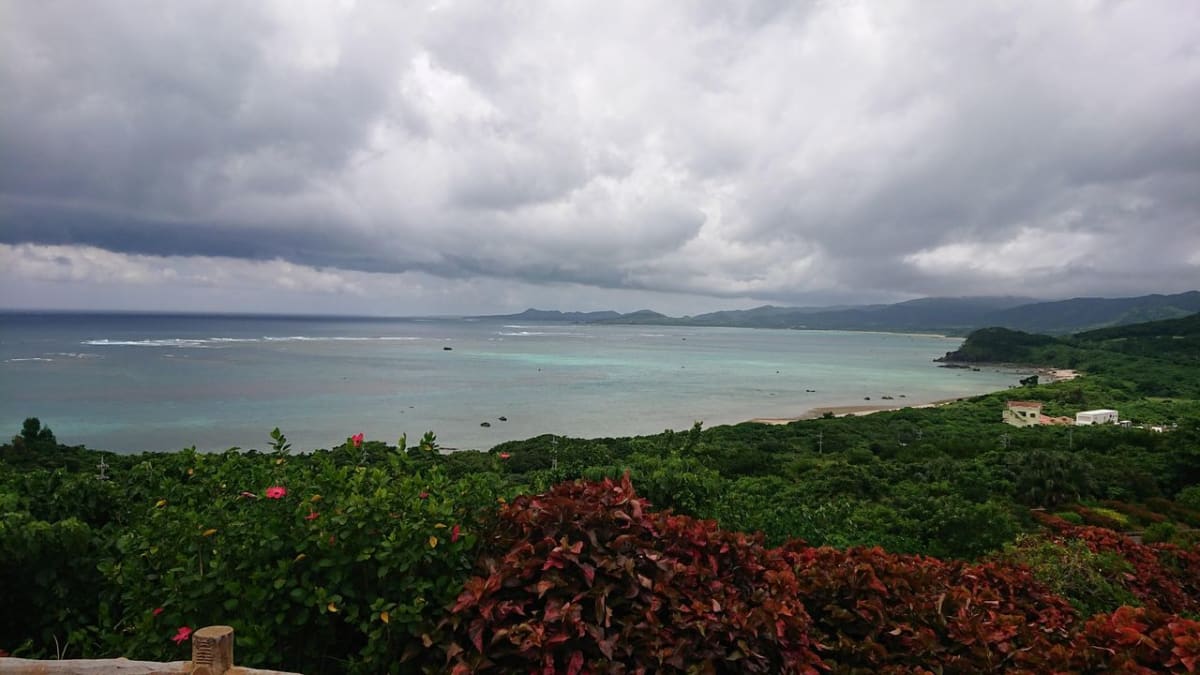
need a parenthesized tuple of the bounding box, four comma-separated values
(427, 477, 1200, 675)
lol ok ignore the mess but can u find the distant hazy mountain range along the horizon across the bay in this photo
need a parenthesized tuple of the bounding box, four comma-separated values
(486, 291, 1200, 335)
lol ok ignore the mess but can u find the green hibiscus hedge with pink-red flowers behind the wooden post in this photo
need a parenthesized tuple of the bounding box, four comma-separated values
(0, 432, 505, 673)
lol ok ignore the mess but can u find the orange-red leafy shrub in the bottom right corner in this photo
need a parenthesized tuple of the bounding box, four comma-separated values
(1070, 607, 1200, 675)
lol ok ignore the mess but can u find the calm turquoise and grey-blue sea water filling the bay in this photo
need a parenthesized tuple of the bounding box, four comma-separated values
(0, 313, 1018, 452)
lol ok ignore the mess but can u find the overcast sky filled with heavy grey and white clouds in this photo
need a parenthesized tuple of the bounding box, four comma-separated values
(0, 0, 1200, 316)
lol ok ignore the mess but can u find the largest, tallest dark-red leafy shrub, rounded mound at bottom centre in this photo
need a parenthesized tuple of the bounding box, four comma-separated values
(440, 477, 821, 674)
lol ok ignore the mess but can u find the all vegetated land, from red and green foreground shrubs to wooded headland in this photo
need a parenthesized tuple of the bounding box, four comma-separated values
(0, 315, 1200, 673)
